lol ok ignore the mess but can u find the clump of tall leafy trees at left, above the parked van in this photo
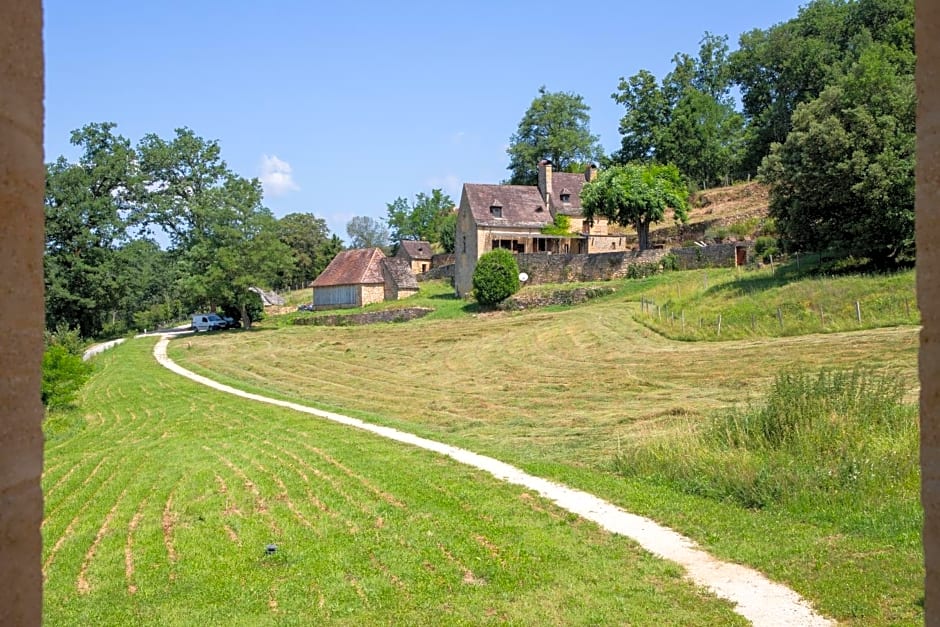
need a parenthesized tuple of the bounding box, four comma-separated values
(44, 123, 322, 337)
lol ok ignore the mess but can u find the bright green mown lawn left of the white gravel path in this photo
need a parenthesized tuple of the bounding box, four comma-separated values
(42, 340, 743, 625)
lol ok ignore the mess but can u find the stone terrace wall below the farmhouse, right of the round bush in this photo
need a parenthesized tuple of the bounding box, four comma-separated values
(516, 250, 668, 285)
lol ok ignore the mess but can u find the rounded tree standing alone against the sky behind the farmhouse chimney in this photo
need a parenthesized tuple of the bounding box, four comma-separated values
(506, 86, 603, 185)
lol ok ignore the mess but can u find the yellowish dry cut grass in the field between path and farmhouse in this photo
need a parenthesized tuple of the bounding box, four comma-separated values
(171, 300, 917, 465)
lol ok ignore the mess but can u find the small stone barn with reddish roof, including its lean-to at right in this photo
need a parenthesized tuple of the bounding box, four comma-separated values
(312, 248, 418, 309)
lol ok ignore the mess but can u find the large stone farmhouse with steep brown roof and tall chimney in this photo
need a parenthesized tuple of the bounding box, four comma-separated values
(454, 161, 630, 297)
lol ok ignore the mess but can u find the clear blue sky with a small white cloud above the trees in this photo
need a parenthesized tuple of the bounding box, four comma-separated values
(44, 0, 805, 239)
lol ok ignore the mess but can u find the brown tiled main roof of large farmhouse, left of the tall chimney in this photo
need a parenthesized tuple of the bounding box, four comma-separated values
(461, 183, 552, 228)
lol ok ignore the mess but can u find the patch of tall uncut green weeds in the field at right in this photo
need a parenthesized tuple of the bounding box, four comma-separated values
(616, 369, 917, 508)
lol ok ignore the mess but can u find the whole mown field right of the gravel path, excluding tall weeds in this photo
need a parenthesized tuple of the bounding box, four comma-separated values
(170, 270, 923, 625)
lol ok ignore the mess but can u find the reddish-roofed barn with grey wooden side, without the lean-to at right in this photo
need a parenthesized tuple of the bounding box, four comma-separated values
(313, 248, 386, 309)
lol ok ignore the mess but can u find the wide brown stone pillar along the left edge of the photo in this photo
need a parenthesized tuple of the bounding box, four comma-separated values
(0, 0, 45, 625)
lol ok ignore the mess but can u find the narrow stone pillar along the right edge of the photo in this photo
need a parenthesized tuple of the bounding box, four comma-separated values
(915, 0, 940, 626)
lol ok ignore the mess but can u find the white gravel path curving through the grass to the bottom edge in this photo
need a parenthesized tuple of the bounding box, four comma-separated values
(153, 336, 833, 627)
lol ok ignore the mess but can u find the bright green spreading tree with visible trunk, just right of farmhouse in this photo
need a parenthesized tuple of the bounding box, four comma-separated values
(581, 163, 688, 250)
